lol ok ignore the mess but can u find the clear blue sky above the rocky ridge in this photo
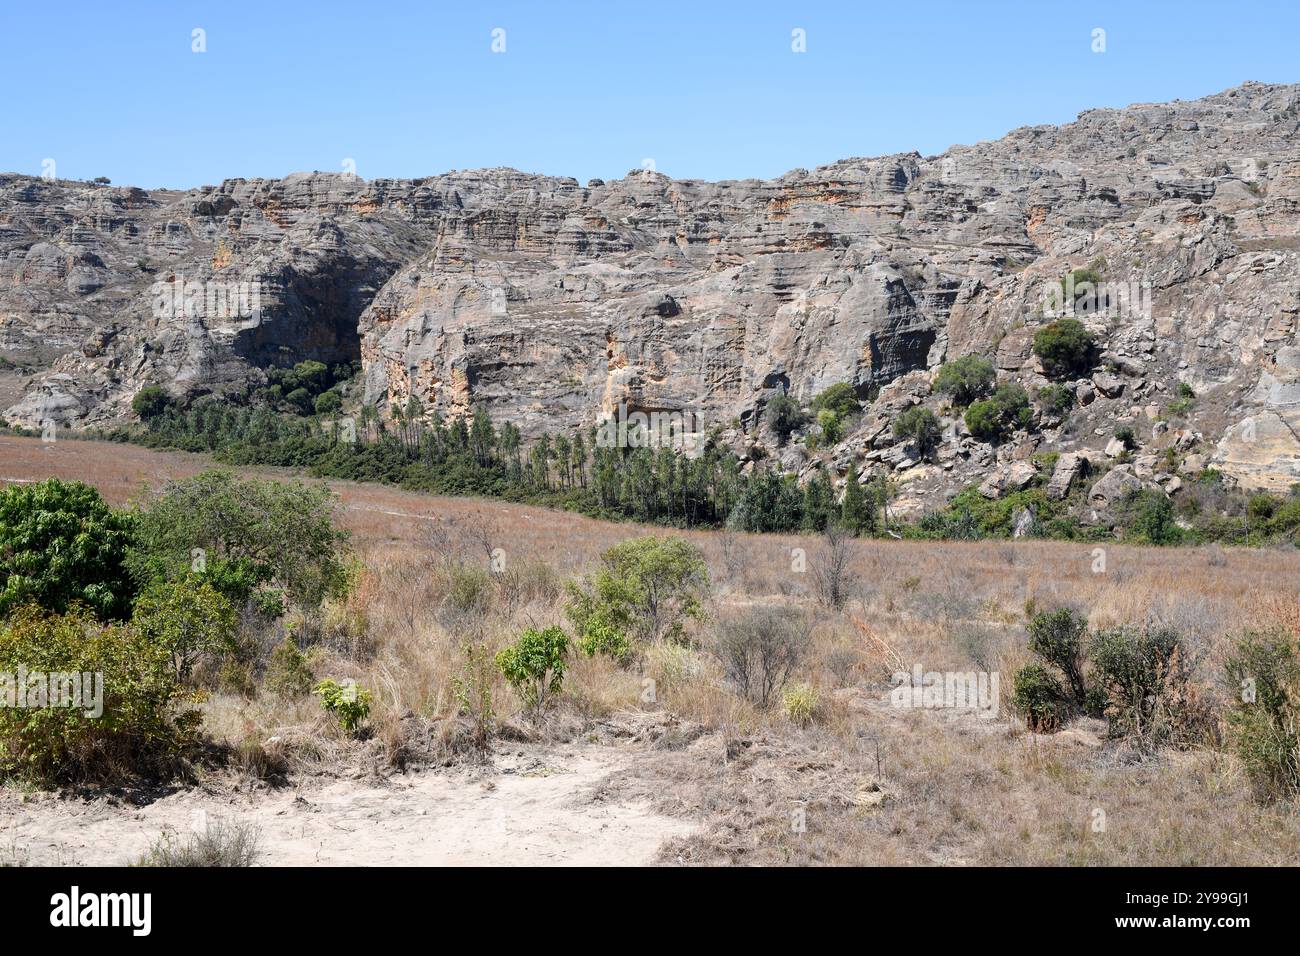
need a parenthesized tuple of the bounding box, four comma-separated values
(0, 0, 1300, 187)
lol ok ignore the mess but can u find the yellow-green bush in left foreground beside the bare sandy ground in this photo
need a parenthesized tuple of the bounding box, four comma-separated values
(0, 606, 202, 784)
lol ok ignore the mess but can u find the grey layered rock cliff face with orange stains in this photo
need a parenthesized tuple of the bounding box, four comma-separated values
(0, 85, 1300, 496)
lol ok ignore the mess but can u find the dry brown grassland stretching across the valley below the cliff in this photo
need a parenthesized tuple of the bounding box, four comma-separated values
(0, 437, 1300, 865)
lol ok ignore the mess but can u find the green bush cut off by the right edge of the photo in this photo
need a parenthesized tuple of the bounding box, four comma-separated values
(1225, 631, 1300, 801)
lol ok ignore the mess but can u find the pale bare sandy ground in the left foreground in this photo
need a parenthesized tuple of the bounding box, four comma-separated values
(0, 745, 692, 866)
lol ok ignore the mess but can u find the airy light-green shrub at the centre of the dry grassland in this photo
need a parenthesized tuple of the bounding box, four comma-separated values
(567, 536, 709, 641)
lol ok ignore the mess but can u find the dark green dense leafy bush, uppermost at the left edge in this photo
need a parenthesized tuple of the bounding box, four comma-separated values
(0, 479, 135, 620)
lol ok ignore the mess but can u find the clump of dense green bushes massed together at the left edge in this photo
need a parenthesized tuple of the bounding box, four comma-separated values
(0, 472, 347, 784)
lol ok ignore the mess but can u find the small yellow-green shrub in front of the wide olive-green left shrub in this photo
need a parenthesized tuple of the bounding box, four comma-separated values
(131, 576, 235, 682)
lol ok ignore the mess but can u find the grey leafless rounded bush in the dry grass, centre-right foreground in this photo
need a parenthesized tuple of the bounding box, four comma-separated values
(714, 607, 811, 708)
